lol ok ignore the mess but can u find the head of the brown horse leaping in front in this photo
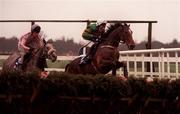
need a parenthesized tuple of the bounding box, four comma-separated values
(119, 23, 135, 49)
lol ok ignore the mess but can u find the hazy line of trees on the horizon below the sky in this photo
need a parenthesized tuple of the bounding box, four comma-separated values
(0, 37, 180, 55)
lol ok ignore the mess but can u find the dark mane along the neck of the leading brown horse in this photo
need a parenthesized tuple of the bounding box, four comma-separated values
(102, 23, 122, 38)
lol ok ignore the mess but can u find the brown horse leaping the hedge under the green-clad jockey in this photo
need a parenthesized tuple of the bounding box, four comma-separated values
(65, 23, 135, 75)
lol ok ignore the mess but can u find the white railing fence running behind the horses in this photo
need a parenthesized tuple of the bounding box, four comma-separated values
(0, 48, 180, 78)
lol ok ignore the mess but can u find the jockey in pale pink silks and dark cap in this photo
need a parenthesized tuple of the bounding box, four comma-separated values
(18, 24, 43, 68)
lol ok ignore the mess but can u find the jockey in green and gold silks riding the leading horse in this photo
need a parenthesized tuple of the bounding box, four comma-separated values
(79, 20, 107, 65)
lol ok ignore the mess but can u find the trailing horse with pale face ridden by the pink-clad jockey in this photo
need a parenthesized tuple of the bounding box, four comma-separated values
(2, 43, 57, 75)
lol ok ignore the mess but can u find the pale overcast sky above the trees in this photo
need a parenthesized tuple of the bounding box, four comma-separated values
(0, 0, 180, 43)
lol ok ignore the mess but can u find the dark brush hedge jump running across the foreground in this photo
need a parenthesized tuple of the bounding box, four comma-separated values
(0, 72, 180, 114)
